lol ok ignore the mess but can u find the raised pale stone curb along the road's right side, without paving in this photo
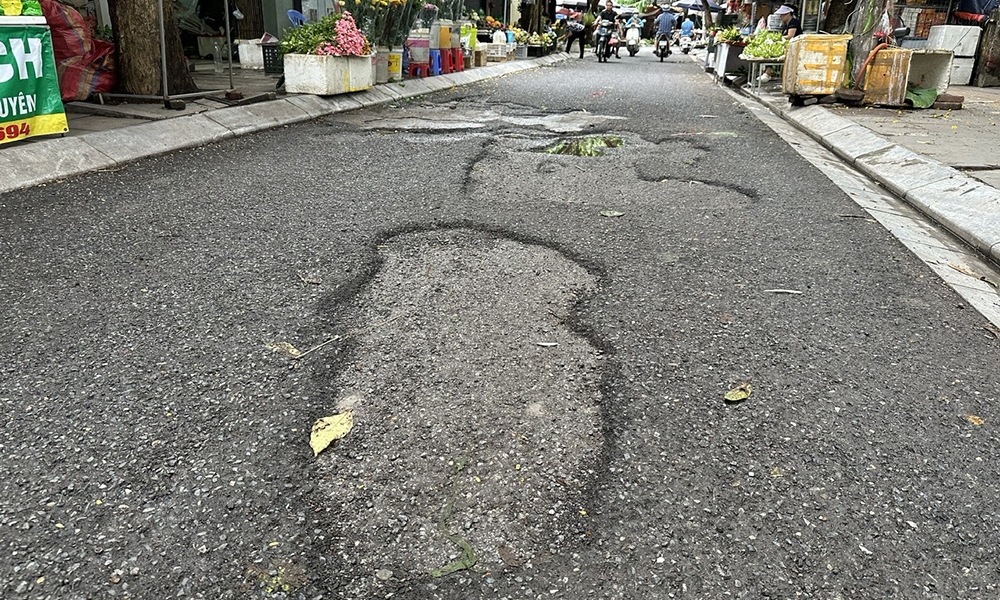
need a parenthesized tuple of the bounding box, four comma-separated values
(741, 90, 1000, 263)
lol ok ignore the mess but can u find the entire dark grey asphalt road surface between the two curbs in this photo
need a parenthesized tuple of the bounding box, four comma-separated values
(0, 51, 1000, 600)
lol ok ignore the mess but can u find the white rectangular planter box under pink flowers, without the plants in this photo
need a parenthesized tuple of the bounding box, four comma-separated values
(284, 54, 375, 96)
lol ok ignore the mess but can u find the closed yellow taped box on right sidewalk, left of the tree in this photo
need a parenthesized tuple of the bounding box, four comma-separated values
(781, 33, 854, 96)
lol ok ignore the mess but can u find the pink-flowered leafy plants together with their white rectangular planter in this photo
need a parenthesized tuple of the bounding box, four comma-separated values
(279, 12, 375, 96)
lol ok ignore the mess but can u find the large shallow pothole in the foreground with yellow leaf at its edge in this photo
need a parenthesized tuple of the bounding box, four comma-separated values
(318, 230, 603, 597)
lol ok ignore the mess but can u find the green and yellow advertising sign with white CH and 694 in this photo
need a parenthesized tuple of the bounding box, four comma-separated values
(0, 25, 69, 144)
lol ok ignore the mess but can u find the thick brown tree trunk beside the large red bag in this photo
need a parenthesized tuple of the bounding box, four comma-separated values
(108, 0, 198, 95)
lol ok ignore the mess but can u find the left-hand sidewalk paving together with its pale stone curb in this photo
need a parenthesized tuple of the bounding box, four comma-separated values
(0, 53, 568, 193)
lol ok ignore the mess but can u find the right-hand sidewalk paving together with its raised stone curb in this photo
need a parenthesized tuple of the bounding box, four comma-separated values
(728, 58, 1000, 263)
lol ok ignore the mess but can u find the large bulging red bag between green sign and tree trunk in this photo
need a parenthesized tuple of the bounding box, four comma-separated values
(40, 0, 117, 102)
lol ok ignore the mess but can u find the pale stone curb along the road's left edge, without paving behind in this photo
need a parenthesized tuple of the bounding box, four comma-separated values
(0, 53, 569, 193)
